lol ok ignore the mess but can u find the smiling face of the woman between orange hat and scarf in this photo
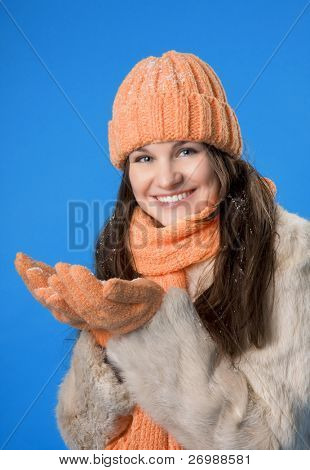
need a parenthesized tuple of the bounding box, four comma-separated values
(128, 141, 219, 226)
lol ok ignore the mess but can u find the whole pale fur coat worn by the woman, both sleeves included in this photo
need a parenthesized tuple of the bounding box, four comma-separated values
(56, 204, 310, 449)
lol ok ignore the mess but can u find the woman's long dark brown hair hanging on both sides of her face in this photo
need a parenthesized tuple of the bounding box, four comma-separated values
(95, 144, 276, 360)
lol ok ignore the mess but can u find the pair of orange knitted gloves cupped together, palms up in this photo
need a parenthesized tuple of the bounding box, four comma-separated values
(15, 253, 165, 346)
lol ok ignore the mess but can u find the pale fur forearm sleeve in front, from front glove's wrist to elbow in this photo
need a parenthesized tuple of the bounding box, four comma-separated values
(107, 287, 279, 449)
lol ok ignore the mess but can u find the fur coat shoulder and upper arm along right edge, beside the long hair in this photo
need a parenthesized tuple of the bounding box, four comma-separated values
(238, 206, 310, 450)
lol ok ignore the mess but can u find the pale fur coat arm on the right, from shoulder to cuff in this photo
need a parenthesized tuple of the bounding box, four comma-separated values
(107, 205, 310, 449)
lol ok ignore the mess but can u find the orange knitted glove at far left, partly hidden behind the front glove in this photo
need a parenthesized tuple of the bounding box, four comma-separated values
(14, 252, 88, 329)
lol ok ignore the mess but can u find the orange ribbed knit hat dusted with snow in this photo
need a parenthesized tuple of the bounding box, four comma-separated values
(108, 50, 242, 169)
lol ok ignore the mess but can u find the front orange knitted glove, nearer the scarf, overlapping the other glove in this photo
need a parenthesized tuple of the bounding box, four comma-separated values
(47, 263, 165, 334)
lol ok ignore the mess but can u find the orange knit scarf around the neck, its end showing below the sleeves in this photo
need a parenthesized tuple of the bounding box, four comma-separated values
(105, 178, 276, 450)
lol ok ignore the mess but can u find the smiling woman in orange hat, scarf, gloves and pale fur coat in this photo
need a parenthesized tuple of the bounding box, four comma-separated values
(15, 51, 310, 449)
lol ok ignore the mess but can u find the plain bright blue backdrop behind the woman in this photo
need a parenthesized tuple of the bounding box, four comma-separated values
(0, 0, 310, 449)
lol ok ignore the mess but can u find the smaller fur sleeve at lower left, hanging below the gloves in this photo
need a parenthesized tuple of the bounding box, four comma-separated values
(55, 330, 134, 450)
